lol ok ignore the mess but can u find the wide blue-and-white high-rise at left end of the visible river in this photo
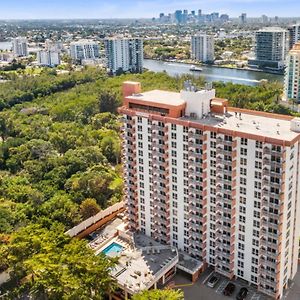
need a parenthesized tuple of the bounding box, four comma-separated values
(104, 38, 144, 74)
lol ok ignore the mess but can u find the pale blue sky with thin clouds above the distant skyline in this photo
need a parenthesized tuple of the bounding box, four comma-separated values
(0, 0, 300, 19)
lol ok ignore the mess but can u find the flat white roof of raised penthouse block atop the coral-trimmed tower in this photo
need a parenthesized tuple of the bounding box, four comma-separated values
(127, 90, 185, 106)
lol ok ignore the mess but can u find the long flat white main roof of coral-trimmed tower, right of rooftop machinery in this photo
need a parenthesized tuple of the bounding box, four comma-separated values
(182, 108, 299, 141)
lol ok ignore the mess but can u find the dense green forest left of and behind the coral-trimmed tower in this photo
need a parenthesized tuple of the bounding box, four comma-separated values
(0, 68, 290, 299)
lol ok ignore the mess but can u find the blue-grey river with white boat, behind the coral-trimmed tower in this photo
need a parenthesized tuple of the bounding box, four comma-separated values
(144, 59, 284, 85)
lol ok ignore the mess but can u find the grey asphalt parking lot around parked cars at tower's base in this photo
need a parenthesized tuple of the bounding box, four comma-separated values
(174, 269, 271, 300)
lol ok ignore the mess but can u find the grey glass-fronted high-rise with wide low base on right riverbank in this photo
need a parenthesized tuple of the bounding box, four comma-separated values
(249, 27, 289, 69)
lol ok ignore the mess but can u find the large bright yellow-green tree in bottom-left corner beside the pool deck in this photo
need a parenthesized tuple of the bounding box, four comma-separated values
(0, 224, 114, 300)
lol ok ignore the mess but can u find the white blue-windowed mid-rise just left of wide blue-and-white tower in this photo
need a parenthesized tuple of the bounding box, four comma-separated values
(70, 40, 100, 61)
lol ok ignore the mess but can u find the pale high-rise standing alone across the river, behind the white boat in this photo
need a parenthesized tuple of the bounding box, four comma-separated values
(191, 33, 215, 62)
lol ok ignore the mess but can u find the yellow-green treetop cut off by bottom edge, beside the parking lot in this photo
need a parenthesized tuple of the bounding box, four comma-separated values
(132, 289, 184, 300)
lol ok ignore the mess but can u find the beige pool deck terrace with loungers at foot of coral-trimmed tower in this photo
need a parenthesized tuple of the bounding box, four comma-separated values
(89, 217, 184, 294)
